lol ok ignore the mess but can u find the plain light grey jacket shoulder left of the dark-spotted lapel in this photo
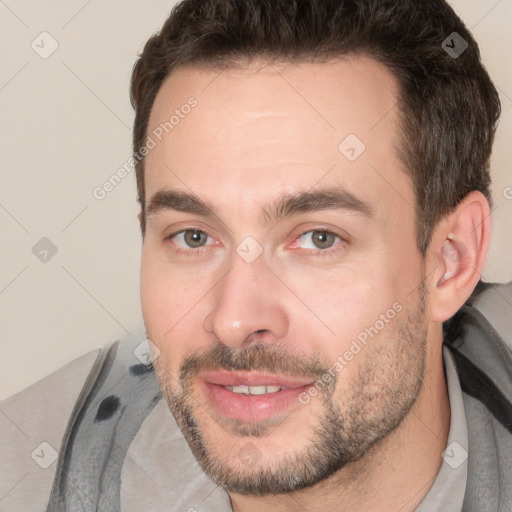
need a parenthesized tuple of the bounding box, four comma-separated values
(0, 338, 110, 512)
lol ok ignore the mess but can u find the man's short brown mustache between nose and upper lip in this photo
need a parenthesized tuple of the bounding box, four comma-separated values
(179, 342, 330, 386)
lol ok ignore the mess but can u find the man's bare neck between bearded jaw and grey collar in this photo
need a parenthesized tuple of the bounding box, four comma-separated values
(230, 341, 450, 512)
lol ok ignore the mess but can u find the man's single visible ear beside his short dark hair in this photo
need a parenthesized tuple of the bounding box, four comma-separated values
(427, 191, 491, 323)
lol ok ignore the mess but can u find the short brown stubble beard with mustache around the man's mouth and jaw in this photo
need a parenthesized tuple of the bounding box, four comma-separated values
(155, 283, 428, 496)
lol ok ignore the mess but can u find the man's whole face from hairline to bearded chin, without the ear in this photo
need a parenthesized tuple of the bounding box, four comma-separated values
(141, 57, 428, 494)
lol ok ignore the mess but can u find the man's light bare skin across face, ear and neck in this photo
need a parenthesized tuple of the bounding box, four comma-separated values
(141, 57, 490, 512)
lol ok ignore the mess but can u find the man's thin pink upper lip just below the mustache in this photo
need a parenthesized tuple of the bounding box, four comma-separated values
(198, 370, 312, 388)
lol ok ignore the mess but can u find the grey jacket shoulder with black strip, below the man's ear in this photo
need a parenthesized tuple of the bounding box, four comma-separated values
(445, 283, 512, 510)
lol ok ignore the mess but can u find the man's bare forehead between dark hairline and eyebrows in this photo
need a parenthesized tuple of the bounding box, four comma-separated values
(142, 56, 414, 224)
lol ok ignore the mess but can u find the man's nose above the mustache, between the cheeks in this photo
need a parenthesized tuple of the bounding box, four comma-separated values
(203, 254, 289, 348)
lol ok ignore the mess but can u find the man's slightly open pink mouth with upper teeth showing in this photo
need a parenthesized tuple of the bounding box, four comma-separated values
(199, 371, 313, 423)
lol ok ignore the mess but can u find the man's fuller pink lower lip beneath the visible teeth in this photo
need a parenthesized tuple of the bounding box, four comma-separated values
(199, 381, 311, 422)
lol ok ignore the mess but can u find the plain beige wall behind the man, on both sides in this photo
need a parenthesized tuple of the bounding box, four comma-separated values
(0, 0, 512, 398)
